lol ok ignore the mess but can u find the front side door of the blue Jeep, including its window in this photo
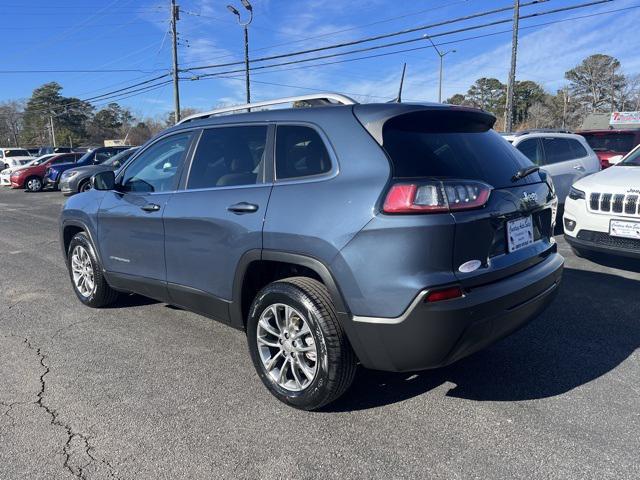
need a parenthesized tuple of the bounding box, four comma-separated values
(97, 131, 194, 298)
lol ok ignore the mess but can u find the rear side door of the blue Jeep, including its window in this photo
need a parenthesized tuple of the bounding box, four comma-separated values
(164, 124, 272, 321)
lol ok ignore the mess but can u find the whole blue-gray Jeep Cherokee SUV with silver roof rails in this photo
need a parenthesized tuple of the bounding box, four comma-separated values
(61, 94, 563, 410)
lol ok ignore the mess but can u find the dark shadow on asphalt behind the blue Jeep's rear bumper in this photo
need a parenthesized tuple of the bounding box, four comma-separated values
(325, 268, 640, 411)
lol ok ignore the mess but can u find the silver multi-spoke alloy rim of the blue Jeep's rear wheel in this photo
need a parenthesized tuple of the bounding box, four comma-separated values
(256, 303, 318, 392)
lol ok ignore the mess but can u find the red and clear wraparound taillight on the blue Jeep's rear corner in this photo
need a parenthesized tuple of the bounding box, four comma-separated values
(383, 180, 492, 213)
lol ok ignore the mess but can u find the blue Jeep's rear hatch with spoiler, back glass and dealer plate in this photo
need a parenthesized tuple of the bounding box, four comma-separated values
(365, 107, 556, 287)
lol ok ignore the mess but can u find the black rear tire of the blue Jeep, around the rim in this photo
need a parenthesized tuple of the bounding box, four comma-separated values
(247, 277, 357, 410)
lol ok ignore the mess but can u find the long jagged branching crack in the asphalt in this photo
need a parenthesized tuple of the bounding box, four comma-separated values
(0, 337, 119, 480)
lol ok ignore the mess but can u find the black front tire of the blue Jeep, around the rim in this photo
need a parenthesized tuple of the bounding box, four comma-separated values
(67, 232, 118, 308)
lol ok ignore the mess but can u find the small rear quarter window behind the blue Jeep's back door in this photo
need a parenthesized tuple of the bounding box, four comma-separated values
(276, 125, 331, 180)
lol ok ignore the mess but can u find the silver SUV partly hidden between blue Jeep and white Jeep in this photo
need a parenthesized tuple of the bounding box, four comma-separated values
(504, 130, 601, 208)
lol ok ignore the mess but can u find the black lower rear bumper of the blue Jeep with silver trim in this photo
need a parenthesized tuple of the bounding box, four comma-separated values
(347, 253, 564, 371)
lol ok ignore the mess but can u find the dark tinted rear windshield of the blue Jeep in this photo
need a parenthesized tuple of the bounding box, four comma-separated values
(382, 110, 540, 187)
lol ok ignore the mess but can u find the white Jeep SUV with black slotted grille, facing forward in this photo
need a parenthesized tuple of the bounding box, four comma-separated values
(563, 146, 640, 258)
